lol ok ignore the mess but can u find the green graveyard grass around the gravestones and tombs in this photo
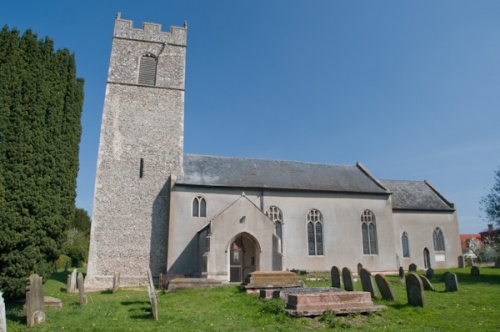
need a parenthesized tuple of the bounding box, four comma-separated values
(3, 267, 500, 332)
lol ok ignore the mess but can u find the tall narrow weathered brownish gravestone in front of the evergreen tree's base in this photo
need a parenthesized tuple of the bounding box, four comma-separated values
(26, 274, 45, 327)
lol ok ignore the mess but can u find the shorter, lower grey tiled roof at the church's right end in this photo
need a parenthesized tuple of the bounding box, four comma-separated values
(380, 180, 455, 211)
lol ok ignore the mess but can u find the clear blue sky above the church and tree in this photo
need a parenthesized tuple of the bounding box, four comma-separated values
(0, 0, 500, 233)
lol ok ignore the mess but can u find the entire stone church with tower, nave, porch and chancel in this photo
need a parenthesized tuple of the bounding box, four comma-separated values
(85, 14, 461, 289)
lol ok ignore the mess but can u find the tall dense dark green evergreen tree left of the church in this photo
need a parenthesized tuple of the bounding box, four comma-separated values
(0, 26, 83, 298)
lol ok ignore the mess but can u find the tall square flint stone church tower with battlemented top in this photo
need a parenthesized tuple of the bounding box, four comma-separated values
(86, 14, 187, 289)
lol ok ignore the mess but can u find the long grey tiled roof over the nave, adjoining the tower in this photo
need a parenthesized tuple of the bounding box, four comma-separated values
(176, 154, 389, 194)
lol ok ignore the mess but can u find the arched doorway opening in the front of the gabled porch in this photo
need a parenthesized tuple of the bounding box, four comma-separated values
(228, 233, 260, 282)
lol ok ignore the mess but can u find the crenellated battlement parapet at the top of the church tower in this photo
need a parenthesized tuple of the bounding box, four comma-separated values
(114, 13, 187, 46)
